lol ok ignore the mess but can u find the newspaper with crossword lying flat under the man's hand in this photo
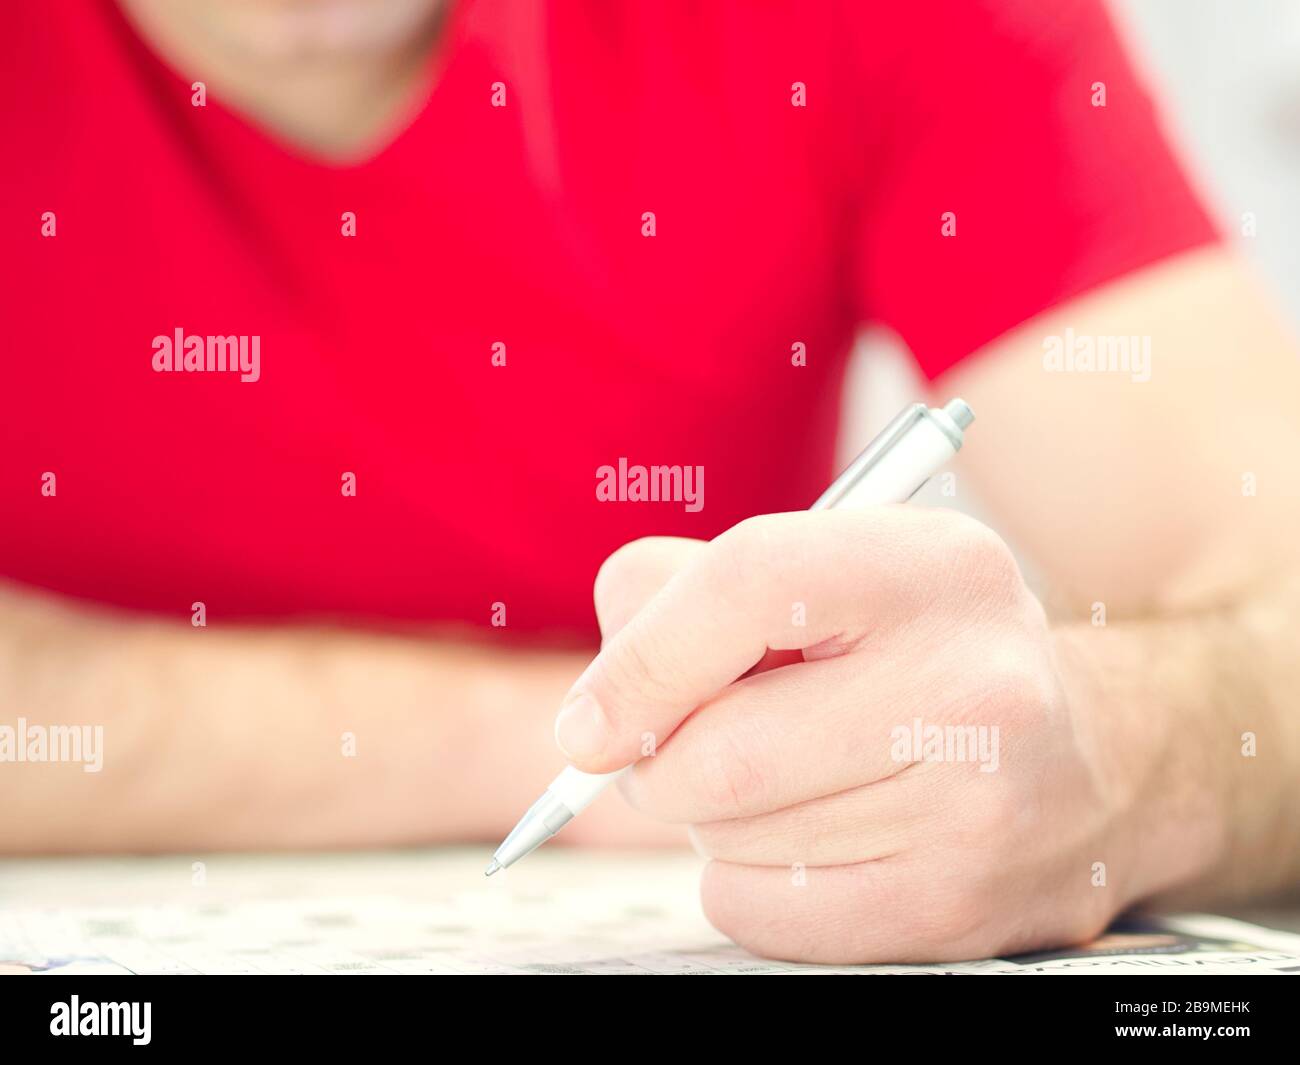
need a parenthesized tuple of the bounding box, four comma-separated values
(0, 848, 1300, 975)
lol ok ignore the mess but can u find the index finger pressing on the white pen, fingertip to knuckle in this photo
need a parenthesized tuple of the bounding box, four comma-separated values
(555, 506, 974, 772)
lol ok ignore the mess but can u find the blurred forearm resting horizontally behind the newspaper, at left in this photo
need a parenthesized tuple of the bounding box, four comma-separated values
(0, 586, 600, 853)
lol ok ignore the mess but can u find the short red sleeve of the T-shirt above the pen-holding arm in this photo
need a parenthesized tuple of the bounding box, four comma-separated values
(849, 0, 1218, 378)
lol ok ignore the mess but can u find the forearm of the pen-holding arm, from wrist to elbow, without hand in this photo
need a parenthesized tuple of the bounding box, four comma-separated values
(1056, 571, 1300, 906)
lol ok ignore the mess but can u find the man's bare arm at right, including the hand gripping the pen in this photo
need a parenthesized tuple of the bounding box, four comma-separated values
(546, 243, 1300, 962)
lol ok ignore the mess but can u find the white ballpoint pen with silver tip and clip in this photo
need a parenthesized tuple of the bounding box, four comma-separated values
(485, 399, 975, 876)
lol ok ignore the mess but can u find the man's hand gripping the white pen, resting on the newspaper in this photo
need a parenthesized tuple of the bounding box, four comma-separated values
(556, 507, 1222, 962)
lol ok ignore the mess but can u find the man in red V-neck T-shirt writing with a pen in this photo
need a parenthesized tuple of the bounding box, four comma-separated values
(0, 0, 1300, 961)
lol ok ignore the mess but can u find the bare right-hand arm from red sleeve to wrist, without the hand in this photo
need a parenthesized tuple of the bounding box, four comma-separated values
(941, 250, 1300, 904)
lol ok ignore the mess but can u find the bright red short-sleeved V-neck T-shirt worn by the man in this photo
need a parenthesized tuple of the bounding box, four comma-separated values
(0, 0, 1214, 635)
